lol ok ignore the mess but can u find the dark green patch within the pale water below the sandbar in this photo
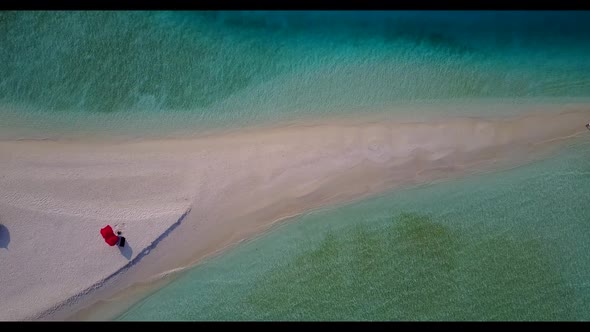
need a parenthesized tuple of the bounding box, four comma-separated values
(238, 213, 576, 320)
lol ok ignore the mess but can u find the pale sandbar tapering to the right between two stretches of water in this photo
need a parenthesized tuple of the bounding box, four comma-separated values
(0, 107, 590, 320)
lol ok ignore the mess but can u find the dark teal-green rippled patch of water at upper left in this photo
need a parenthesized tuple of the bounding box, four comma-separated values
(0, 11, 290, 113)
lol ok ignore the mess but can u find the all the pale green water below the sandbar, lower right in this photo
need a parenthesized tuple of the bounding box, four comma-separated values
(116, 138, 590, 320)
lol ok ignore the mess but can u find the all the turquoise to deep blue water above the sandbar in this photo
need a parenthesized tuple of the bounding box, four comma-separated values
(0, 11, 590, 138)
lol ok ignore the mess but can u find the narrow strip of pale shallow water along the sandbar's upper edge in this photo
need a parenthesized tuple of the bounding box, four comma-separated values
(0, 97, 590, 144)
